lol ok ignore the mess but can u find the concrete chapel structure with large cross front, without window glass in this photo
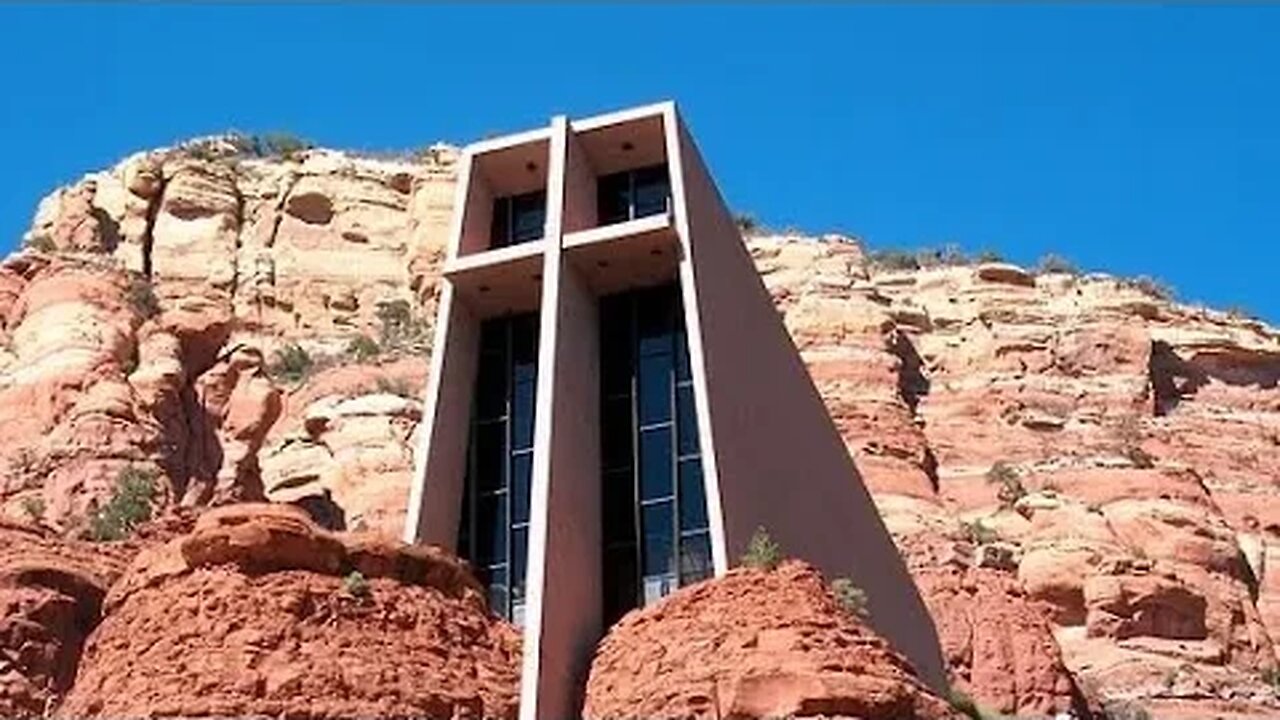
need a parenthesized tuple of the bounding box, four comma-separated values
(404, 102, 945, 720)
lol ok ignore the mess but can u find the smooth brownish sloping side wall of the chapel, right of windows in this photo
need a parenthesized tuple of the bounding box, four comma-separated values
(676, 109, 946, 689)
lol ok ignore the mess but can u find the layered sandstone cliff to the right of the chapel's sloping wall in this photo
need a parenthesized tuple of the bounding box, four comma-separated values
(755, 244, 1280, 717)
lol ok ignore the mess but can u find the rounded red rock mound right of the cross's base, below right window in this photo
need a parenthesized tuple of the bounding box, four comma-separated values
(584, 561, 963, 720)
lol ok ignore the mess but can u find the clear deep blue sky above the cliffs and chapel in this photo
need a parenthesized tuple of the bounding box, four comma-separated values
(0, 4, 1280, 316)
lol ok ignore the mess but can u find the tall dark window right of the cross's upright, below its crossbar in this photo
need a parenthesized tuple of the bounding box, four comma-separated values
(600, 284, 713, 623)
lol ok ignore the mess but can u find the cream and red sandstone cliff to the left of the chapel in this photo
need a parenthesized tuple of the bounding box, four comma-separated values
(0, 138, 453, 532)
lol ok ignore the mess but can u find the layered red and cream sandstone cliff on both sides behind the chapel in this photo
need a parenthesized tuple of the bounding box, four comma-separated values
(10, 140, 1280, 717)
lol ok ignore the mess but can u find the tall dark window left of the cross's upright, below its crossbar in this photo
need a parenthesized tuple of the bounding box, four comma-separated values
(458, 313, 538, 624)
